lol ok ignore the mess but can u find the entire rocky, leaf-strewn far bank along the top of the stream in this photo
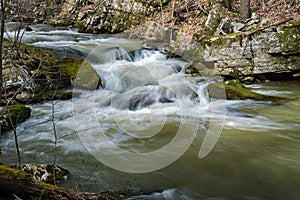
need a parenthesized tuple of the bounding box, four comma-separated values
(6, 0, 300, 80)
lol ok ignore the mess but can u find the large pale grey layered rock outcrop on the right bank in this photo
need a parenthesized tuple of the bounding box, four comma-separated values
(195, 26, 300, 78)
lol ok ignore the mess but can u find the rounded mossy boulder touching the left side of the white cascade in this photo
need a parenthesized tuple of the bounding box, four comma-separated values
(59, 59, 101, 90)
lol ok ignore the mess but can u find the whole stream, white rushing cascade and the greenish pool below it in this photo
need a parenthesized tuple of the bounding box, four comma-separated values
(0, 26, 300, 200)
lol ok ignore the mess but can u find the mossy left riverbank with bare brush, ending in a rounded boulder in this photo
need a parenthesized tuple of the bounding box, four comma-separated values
(0, 37, 100, 131)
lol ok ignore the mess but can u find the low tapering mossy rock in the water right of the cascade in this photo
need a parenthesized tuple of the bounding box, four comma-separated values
(207, 83, 286, 102)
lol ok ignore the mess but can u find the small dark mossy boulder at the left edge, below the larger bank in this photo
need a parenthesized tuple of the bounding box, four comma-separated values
(0, 104, 31, 131)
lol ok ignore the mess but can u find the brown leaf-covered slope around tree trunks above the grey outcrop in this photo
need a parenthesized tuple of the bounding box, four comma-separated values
(132, 0, 300, 44)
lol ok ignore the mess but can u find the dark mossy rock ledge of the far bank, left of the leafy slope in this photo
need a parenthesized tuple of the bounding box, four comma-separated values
(9, 0, 171, 33)
